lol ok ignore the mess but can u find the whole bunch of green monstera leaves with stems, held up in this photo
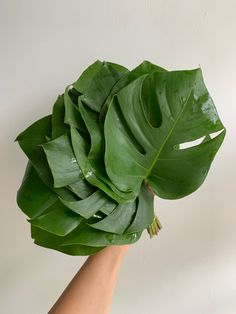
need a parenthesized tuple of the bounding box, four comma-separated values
(16, 61, 226, 255)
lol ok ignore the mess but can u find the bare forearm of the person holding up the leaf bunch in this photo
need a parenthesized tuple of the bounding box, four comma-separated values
(48, 245, 129, 314)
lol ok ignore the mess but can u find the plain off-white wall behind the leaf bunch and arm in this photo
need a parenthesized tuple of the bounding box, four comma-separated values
(0, 0, 236, 314)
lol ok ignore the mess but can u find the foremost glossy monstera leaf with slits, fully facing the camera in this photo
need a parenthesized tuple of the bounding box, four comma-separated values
(104, 69, 225, 199)
